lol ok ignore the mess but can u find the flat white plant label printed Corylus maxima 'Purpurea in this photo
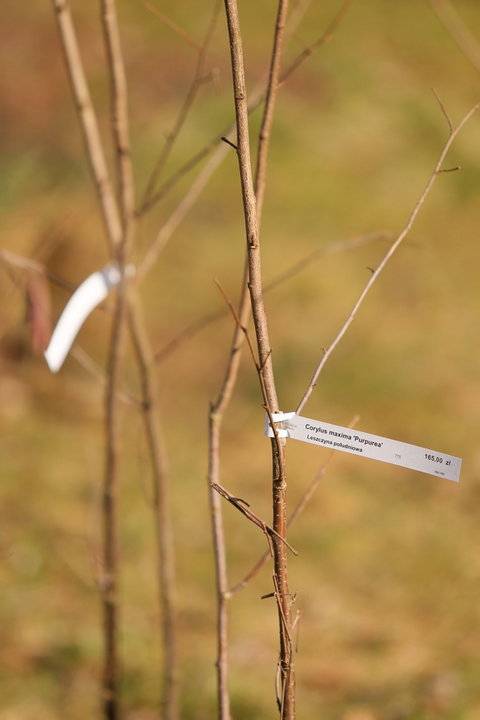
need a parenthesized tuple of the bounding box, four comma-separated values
(266, 413, 462, 482)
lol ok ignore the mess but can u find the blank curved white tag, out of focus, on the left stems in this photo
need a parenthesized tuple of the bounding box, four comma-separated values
(44, 265, 133, 373)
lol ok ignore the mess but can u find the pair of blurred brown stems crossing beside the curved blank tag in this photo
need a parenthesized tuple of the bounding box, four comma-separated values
(53, 0, 178, 720)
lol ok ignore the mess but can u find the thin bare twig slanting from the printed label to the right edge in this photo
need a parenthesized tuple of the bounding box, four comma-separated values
(295, 103, 480, 414)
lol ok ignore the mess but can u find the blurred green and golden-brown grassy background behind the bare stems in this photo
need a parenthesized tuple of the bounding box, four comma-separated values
(0, 0, 480, 720)
